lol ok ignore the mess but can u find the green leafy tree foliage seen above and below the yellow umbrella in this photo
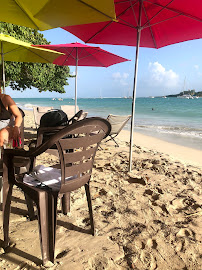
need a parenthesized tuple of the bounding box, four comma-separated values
(0, 22, 69, 93)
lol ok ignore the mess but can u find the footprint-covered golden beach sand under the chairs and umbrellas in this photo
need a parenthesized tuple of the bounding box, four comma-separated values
(0, 111, 202, 270)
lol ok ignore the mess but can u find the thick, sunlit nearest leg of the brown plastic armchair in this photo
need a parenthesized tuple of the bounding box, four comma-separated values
(36, 191, 58, 265)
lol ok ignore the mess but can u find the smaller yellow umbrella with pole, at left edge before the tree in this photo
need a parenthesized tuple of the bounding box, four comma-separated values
(0, 34, 63, 92)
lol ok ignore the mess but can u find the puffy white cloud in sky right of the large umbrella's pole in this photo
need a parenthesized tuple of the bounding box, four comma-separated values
(149, 62, 179, 88)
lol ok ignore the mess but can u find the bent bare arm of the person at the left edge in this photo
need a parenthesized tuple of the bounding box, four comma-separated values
(4, 95, 22, 140)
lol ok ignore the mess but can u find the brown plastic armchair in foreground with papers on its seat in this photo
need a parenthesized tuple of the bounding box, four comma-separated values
(3, 117, 111, 264)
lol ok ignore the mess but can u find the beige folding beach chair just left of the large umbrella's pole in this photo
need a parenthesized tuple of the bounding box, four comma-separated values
(106, 114, 131, 147)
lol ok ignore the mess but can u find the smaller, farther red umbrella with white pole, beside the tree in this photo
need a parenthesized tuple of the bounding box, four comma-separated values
(33, 42, 130, 113)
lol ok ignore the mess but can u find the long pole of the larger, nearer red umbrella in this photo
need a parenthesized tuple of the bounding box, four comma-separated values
(128, 1, 142, 172)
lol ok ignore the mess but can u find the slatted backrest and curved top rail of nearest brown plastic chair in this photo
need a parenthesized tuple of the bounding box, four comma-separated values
(25, 117, 111, 189)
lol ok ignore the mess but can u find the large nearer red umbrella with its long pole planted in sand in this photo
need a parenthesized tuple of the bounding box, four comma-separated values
(63, 0, 202, 170)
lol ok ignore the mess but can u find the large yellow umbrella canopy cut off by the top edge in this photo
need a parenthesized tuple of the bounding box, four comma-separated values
(0, 0, 116, 30)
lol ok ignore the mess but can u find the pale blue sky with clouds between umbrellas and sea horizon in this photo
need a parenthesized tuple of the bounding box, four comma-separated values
(6, 28, 202, 98)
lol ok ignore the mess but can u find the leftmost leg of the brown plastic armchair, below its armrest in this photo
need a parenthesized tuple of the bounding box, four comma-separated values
(3, 181, 13, 248)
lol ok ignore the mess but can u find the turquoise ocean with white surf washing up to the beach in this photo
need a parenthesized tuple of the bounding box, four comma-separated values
(14, 97, 202, 150)
